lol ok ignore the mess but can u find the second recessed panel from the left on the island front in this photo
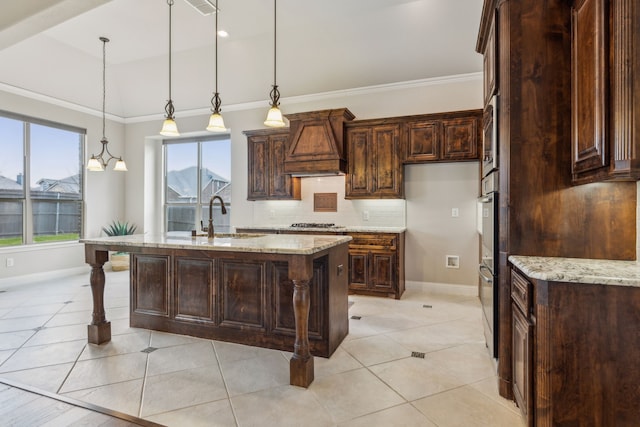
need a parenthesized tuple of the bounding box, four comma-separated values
(175, 258, 216, 322)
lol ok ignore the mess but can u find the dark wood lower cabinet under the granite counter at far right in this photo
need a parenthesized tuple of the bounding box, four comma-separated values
(511, 267, 640, 427)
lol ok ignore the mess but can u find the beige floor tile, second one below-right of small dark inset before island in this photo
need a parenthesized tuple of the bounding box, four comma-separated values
(141, 366, 228, 417)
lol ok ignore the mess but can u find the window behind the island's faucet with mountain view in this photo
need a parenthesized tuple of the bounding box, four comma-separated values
(164, 135, 231, 231)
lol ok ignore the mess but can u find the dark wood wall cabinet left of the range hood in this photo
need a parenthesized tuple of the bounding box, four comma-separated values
(244, 129, 301, 200)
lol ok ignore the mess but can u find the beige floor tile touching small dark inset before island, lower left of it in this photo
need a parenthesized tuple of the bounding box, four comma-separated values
(60, 353, 147, 393)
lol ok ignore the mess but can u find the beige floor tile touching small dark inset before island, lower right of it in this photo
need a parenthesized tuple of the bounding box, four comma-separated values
(147, 341, 218, 375)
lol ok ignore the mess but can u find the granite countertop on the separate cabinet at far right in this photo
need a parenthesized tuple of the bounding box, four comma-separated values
(509, 255, 640, 287)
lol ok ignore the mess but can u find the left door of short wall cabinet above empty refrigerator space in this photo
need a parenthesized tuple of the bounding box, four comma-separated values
(405, 120, 442, 163)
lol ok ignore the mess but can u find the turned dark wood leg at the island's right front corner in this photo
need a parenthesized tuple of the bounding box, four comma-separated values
(289, 256, 314, 387)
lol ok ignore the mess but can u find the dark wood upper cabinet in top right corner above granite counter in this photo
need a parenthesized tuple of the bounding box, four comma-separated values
(571, 0, 640, 184)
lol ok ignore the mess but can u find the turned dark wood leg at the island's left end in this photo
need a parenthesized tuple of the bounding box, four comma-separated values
(85, 246, 111, 344)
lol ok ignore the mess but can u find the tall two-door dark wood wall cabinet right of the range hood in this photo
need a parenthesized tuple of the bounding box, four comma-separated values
(345, 120, 404, 199)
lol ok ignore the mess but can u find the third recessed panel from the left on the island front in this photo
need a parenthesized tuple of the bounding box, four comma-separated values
(219, 259, 266, 329)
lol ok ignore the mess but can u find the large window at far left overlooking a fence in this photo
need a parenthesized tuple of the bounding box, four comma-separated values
(0, 112, 85, 247)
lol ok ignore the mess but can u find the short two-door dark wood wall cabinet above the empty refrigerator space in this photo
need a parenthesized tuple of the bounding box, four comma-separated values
(402, 110, 482, 163)
